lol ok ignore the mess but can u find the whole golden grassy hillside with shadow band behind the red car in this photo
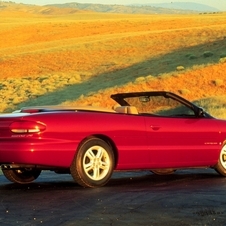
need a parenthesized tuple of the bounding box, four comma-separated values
(0, 3, 226, 118)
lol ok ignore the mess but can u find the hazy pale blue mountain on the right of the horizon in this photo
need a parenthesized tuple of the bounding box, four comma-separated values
(132, 2, 220, 12)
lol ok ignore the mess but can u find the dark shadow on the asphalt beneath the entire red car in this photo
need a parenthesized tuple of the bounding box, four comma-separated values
(0, 170, 222, 192)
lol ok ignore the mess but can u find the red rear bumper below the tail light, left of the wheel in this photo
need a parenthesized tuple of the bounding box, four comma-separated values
(0, 140, 77, 168)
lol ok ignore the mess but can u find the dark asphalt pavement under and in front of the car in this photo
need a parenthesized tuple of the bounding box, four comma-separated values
(0, 169, 226, 226)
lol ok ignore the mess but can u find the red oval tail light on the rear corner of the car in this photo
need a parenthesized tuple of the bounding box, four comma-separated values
(9, 120, 46, 134)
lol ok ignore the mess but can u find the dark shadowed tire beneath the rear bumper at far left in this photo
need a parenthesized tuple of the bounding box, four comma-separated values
(2, 168, 41, 184)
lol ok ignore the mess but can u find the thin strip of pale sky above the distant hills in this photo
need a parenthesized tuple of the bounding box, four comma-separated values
(12, 0, 226, 10)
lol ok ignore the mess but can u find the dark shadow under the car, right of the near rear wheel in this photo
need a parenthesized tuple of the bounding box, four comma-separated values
(107, 169, 225, 190)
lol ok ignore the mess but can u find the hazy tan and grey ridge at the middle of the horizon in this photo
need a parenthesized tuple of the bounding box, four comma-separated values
(46, 2, 198, 14)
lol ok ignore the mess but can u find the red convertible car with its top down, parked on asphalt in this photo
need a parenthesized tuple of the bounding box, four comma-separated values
(0, 91, 226, 187)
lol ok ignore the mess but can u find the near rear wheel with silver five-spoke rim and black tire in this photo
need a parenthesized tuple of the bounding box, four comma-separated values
(70, 137, 115, 188)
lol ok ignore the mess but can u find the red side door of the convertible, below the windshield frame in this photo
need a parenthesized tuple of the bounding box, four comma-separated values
(145, 116, 221, 168)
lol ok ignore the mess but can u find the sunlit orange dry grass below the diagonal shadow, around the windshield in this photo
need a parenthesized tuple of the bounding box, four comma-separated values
(64, 63, 226, 119)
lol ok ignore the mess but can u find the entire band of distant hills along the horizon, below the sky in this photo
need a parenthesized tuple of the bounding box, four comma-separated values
(0, 0, 218, 15)
